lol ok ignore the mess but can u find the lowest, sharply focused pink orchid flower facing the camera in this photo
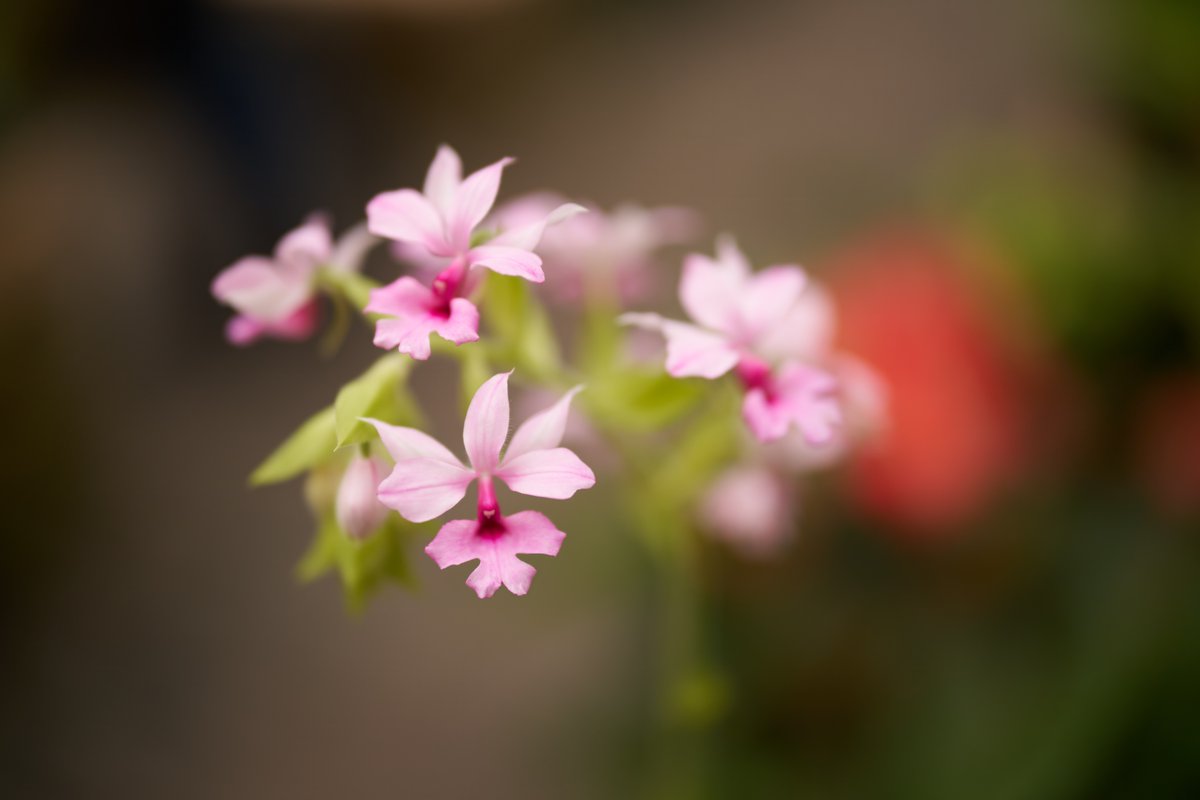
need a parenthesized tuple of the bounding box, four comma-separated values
(368, 373, 595, 597)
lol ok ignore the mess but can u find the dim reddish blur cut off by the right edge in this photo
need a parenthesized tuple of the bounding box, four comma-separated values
(1138, 374, 1200, 516)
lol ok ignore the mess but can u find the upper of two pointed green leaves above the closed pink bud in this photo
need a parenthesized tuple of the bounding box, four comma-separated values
(334, 353, 416, 447)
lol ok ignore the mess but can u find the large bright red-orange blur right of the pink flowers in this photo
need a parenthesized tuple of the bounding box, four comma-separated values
(828, 234, 1032, 537)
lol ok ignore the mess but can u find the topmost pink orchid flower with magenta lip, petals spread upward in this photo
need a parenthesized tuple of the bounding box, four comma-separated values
(366, 145, 586, 361)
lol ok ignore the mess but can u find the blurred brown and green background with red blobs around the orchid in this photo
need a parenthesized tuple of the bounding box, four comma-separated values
(0, 0, 1200, 799)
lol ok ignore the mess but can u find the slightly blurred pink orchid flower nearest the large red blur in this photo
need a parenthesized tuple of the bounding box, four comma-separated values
(620, 237, 841, 444)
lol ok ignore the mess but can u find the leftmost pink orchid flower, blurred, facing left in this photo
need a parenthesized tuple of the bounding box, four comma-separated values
(212, 215, 377, 345)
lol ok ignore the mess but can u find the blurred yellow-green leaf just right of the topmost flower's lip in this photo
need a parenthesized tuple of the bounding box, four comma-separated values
(484, 275, 562, 381)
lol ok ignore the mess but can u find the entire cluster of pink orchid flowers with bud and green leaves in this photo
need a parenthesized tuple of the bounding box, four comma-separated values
(212, 146, 878, 597)
